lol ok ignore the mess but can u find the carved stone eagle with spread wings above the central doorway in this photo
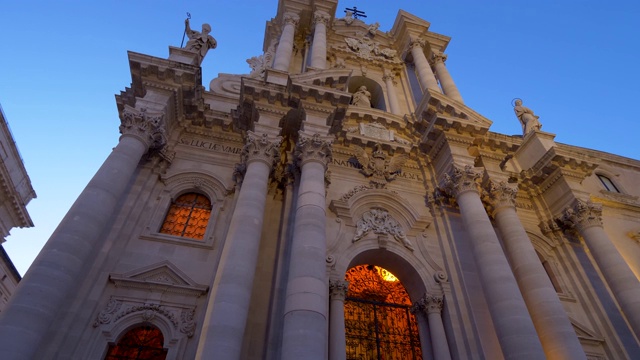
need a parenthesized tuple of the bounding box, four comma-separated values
(356, 144, 409, 189)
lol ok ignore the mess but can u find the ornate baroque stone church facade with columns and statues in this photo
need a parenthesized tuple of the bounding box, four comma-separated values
(0, 0, 640, 360)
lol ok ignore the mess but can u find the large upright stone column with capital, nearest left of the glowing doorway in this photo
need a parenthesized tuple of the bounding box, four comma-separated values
(282, 133, 331, 360)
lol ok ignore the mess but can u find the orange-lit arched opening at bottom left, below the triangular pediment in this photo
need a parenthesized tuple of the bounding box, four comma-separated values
(105, 325, 167, 360)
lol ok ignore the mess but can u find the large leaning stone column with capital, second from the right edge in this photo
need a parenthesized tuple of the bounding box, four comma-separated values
(486, 181, 586, 360)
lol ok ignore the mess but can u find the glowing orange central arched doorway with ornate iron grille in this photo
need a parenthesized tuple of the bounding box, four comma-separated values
(344, 265, 422, 360)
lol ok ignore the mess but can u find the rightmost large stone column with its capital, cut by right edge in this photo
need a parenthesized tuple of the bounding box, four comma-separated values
(562, 200, 640, 338)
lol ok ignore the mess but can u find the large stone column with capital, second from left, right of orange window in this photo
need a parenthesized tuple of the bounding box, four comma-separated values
(197, 132, 281, 360)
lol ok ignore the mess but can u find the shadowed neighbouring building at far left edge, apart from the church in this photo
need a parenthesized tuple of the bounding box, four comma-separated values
(0, 106, 36, 312)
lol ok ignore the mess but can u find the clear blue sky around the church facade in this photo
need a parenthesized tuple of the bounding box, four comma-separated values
(0, 0, 640, 274)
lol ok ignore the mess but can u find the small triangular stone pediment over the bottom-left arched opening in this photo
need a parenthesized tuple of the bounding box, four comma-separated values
(109, 261, 209, 296)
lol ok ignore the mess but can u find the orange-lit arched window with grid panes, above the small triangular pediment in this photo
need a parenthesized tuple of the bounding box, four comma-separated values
(160, 193, 211, 240)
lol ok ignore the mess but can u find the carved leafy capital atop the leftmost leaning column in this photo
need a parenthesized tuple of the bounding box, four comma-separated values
(120, 105, 167, 149)
